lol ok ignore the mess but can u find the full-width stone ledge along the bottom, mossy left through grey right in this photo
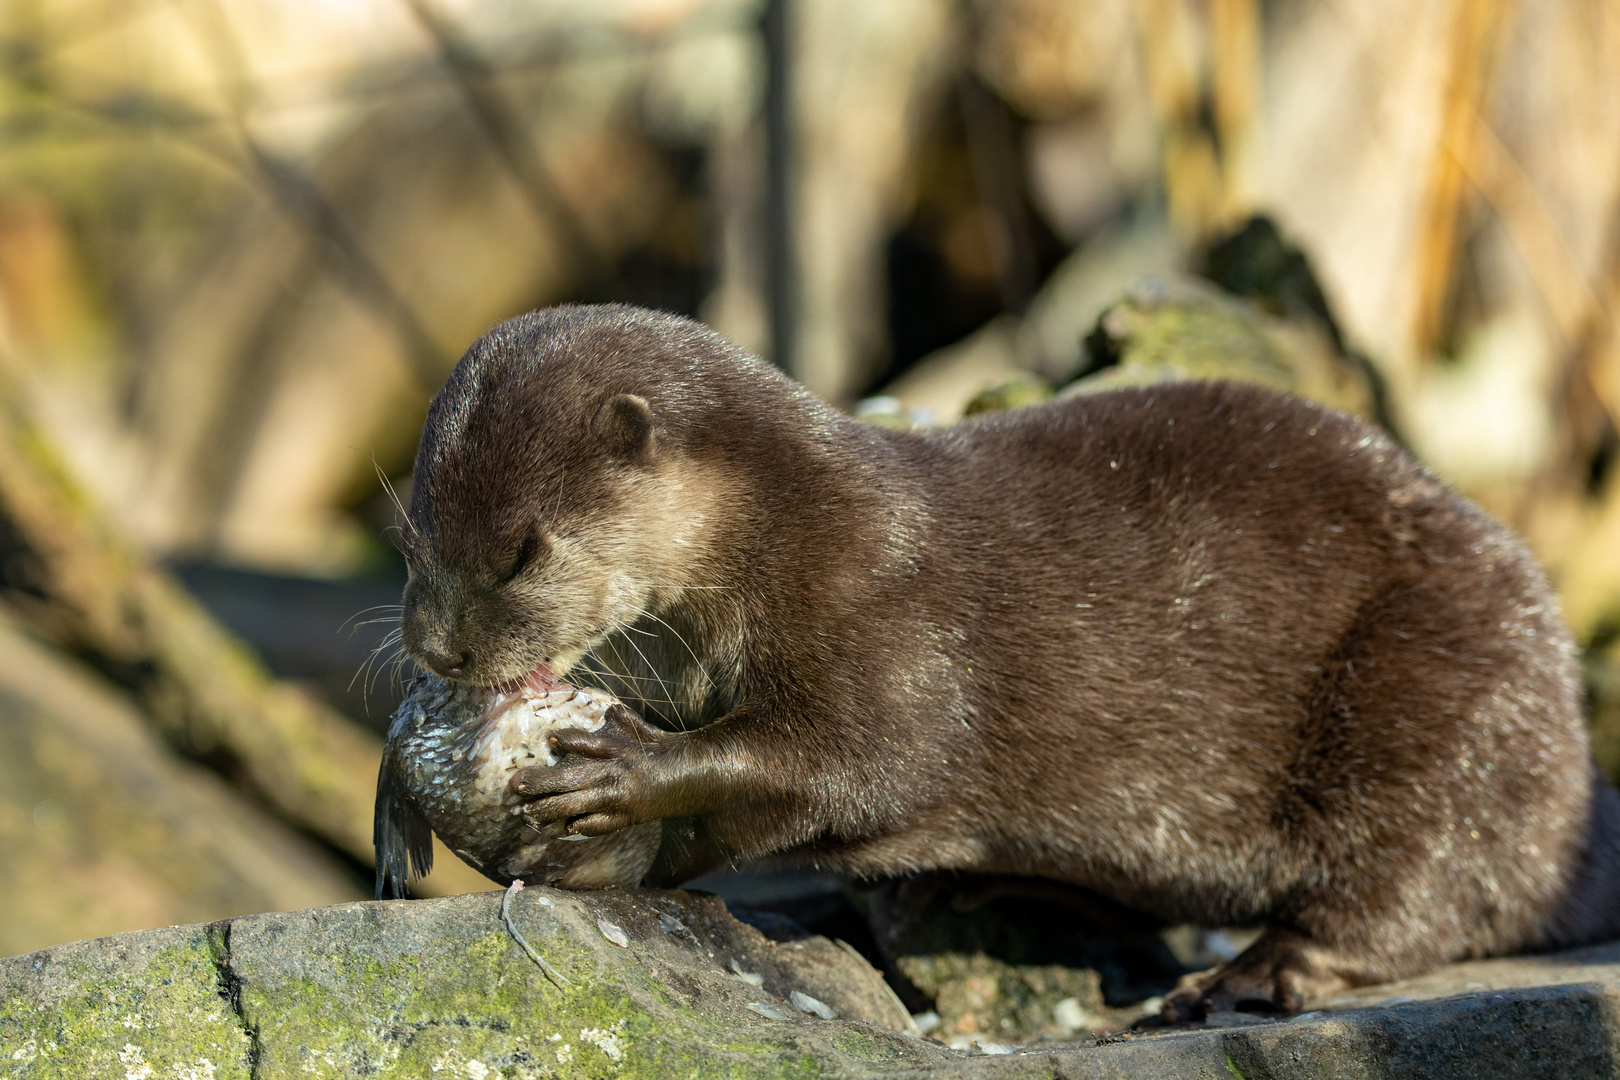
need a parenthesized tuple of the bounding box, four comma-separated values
(0, 889, 1620, 1080)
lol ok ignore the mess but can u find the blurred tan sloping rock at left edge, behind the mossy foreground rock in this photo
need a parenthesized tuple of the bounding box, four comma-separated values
(0, 619, 365, 958)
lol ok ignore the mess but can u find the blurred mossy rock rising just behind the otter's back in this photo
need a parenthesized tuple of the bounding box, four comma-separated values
(883, 226, 1388, 426)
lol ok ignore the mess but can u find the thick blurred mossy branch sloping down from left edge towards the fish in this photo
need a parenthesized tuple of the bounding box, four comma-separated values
(0, 385, 381, 863)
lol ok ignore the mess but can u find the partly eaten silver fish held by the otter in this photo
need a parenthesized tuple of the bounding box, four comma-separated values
(373, 675, 663, 900)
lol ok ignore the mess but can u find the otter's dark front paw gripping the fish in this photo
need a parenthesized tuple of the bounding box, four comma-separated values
(512, 704, 677, 836)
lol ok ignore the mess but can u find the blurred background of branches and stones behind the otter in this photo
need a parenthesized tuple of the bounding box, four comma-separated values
(0, 0, 1620, 955)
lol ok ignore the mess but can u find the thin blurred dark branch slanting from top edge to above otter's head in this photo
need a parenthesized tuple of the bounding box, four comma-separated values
(403, 0, 612, 291)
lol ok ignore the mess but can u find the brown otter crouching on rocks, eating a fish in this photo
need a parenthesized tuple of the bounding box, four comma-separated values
(403, 299, 1620, 1017)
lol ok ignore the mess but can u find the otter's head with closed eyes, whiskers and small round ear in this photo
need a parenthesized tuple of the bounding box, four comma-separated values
(402, 308, 741, 687)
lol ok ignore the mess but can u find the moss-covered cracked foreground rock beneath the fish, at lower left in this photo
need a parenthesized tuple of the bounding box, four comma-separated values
(0, 889, 948, 1080)
